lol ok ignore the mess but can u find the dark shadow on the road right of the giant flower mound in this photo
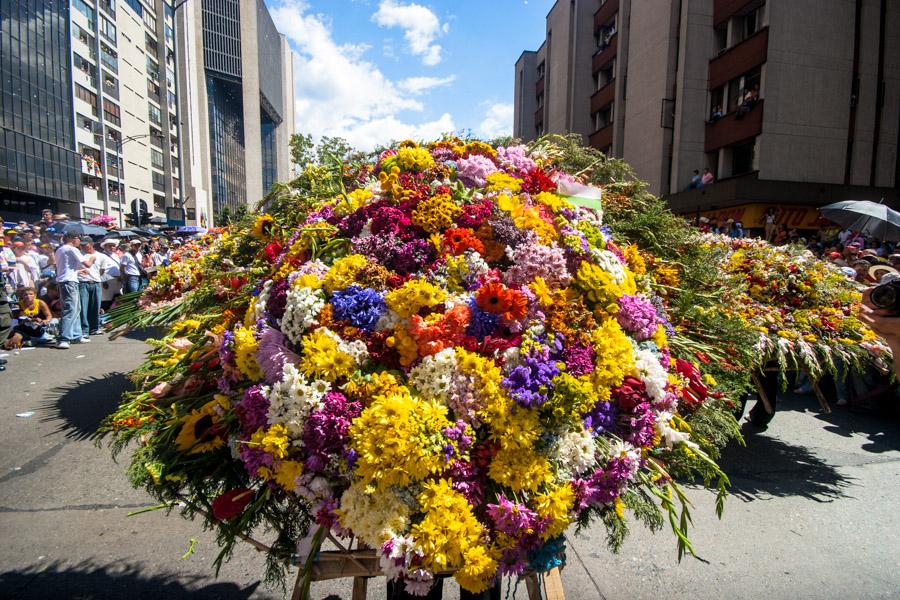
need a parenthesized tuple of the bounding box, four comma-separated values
(719, 426, 853, 502)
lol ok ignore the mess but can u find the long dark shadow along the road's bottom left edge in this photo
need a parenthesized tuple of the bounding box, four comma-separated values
(0, 561, 264, 600)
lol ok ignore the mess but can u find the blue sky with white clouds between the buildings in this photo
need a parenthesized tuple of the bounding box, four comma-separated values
(267, 0, 553, 149)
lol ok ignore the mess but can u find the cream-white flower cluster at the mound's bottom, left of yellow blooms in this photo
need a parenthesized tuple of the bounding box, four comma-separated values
(335, 481, 409, 548)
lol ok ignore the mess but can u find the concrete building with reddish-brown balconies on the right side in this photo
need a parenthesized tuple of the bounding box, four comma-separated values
(514, 0, 900, 229)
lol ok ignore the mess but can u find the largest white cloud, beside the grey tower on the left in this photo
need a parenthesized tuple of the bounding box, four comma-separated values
(269, 0, 454, 150)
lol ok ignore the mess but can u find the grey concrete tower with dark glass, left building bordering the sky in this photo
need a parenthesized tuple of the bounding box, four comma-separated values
(178, 0, 294, 224)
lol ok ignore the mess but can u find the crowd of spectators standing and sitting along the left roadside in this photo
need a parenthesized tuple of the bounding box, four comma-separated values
(0, 211, 188, 371)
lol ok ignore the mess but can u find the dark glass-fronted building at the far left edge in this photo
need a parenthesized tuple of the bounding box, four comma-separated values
(0, 0, 81, 218)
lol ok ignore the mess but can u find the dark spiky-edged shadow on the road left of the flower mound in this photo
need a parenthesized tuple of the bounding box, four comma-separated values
(40, 372, 132, 440)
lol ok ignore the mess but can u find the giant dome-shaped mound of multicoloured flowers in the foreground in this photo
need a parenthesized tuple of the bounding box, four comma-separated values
(105, 139, 733, 593)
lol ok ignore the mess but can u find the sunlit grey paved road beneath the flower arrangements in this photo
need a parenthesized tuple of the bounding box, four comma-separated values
(0, 338, 900, 600)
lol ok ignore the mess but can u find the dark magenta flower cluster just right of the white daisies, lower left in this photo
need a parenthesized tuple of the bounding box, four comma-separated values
(303, 390, 362, 472)
